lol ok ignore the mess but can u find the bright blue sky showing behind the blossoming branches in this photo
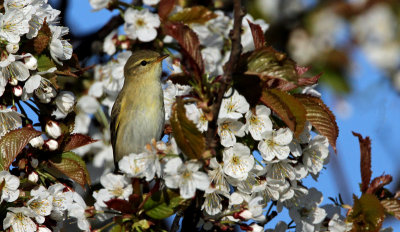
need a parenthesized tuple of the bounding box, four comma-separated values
(50, 0, 400, 230)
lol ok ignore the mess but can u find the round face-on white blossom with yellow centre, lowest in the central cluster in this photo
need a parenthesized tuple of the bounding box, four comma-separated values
(223, 143, 255, 180)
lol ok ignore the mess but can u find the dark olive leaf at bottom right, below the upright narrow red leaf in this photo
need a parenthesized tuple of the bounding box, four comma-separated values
(348, 194, 385, 231)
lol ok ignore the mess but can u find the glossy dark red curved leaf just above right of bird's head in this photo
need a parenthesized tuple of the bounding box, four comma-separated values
(164, 22, 204, 78)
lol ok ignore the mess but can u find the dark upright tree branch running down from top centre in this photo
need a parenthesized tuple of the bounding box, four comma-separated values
(206, 0, 245, 152)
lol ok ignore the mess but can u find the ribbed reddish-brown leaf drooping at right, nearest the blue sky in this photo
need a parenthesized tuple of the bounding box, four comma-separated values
(295, 94, 339, 152)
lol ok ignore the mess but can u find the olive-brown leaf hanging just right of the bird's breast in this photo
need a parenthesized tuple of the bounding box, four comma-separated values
(170, 98, 206, 159)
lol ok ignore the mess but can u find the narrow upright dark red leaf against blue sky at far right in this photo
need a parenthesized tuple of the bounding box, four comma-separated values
(353, 131, 372, 193)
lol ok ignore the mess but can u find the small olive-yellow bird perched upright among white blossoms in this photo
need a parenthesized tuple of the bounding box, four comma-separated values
(110, 50, 168, 170)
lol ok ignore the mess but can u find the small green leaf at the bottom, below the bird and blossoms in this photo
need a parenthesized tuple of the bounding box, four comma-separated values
(143, 190, 185, 220)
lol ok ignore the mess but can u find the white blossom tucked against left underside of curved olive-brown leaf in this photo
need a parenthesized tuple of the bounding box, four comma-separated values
(245, 105, 272, 141)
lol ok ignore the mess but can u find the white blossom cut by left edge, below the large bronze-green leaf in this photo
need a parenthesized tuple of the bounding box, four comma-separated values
(0, 171, 19, 203)
